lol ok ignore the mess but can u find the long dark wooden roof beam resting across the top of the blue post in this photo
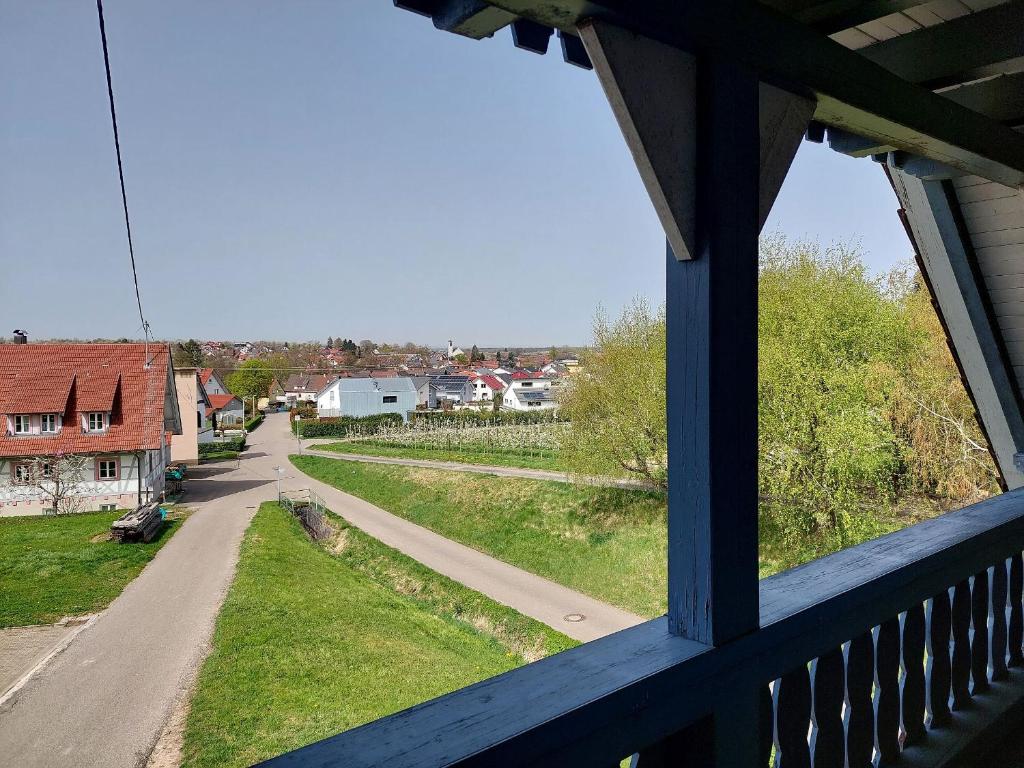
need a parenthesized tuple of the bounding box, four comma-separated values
(479, 0, 1024, 186)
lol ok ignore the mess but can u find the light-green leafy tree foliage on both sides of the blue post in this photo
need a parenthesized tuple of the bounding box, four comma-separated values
(561, 238, 997, 546)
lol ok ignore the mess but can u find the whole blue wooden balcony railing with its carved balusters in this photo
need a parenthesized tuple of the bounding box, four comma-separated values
(258, 490, 1024, 768)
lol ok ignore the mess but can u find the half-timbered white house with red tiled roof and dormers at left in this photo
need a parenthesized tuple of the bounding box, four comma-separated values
(0, 344, 181, 515)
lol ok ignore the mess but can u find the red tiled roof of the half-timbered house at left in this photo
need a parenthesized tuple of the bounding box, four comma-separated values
(0, 344, 171, 457)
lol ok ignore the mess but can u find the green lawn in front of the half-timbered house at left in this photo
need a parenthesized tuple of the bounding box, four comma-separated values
(0, 512, 181, 627)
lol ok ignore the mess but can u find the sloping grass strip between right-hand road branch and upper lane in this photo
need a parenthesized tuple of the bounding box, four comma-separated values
(291, 456, 667, 616)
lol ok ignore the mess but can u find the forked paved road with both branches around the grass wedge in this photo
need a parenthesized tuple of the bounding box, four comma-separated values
(0, 414, 643, 768)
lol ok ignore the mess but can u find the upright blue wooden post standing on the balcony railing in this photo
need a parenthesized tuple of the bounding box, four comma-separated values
(666, 57, 759, 645)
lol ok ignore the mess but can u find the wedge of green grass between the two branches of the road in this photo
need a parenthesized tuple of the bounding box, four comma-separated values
(183, 503, 574, 768)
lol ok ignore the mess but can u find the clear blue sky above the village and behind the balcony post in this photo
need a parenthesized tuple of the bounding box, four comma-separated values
(0, 0, 910, 346)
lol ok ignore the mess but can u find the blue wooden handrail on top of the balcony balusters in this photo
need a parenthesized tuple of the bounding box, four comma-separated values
(262, 490, 1024, 768)
